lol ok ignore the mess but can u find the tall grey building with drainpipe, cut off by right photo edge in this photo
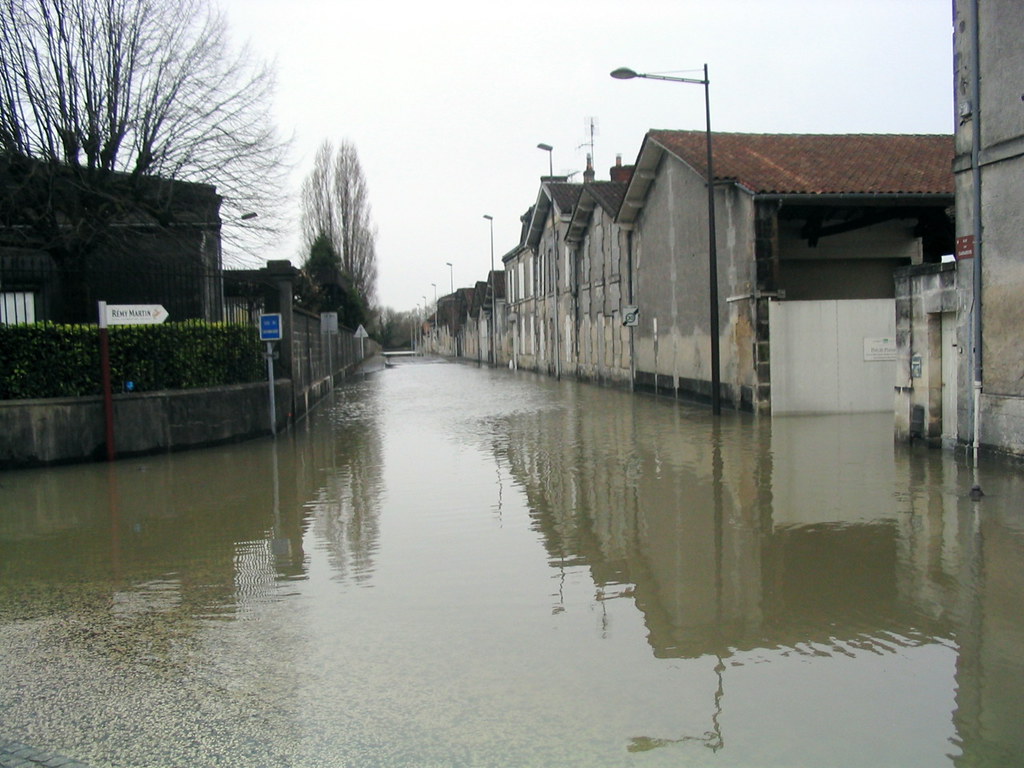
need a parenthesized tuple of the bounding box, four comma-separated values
(953, 0, 1024, 454)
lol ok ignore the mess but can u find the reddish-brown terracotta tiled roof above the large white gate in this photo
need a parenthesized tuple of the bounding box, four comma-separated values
(648, 130, 954, 195)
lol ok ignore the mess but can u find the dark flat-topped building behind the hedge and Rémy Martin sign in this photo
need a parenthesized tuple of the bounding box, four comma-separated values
(0, 156, 223, 323)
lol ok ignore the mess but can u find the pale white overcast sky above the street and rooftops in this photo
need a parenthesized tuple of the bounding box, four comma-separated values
(214, 0, 953, 310)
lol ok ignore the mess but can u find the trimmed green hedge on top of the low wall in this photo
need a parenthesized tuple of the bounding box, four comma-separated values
(0, 322, 266, 399)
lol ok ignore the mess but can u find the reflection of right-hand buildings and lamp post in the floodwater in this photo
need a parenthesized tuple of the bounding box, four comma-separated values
(485, 390, 1024, 765)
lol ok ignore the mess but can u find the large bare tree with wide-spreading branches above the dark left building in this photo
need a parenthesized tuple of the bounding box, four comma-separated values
(0, 0, 286, 268)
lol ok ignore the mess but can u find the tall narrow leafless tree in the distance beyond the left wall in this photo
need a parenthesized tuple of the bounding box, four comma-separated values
(302, 140, 377, 306)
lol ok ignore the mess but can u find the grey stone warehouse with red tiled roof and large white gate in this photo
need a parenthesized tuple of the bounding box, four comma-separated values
(616, 131, 953, 414)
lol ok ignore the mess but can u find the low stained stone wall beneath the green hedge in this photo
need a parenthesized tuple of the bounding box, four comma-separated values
(0, 379, 292, 469)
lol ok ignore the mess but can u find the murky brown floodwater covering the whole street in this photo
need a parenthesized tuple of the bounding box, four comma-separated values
(0, 360, 1024, 768)
